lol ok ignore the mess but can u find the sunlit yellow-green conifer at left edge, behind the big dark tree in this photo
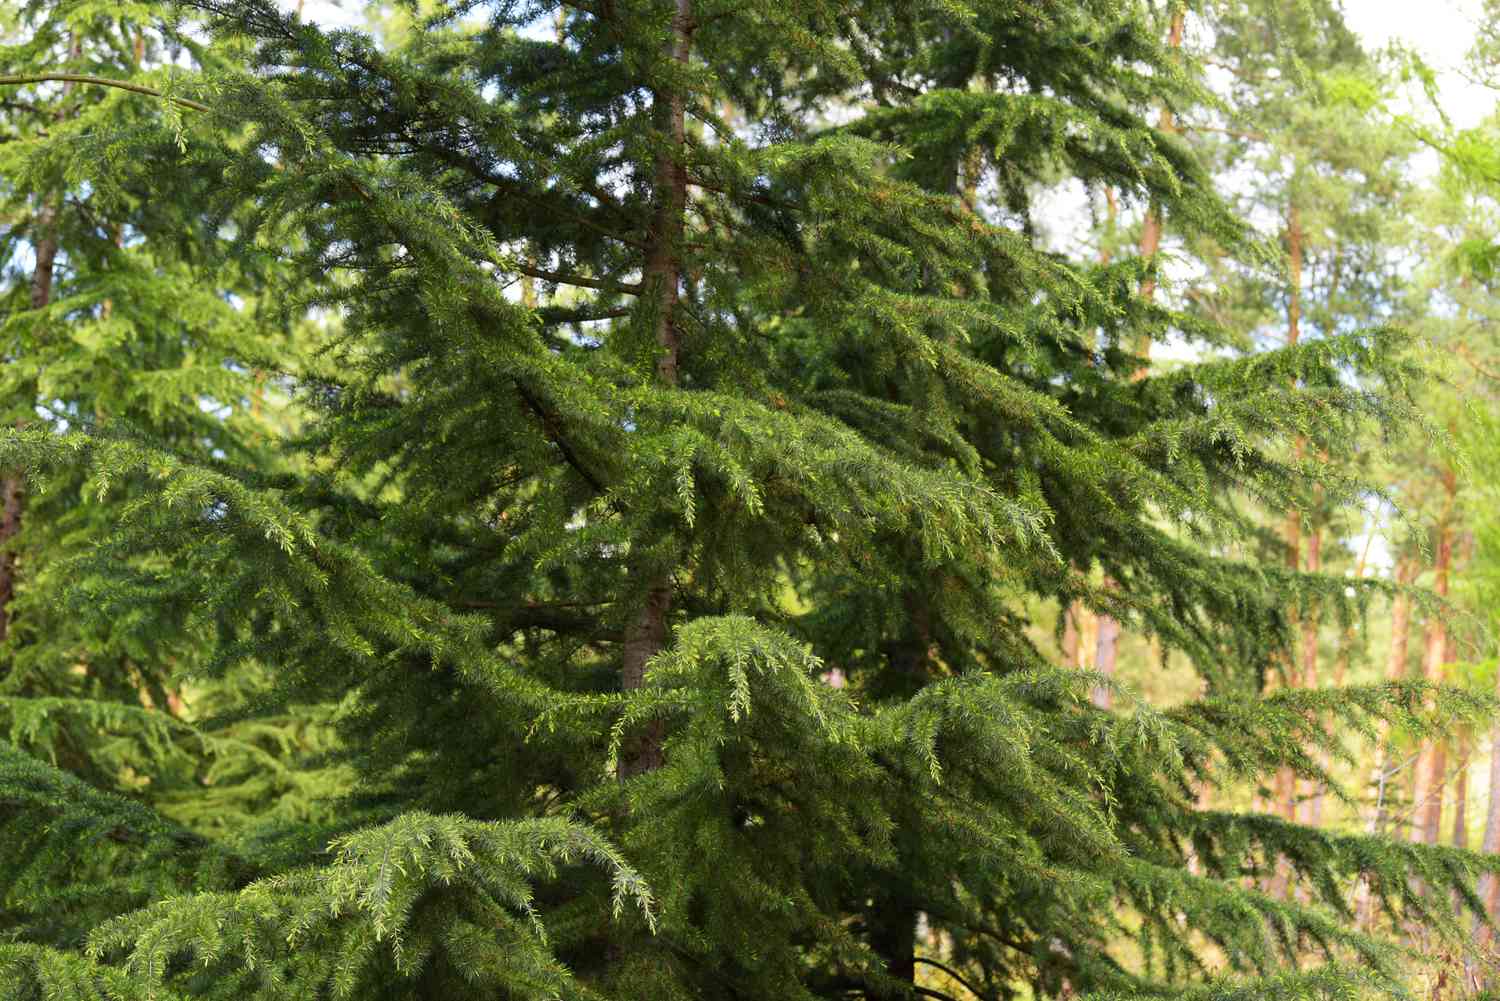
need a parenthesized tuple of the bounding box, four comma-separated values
(0, 3, 345, 972)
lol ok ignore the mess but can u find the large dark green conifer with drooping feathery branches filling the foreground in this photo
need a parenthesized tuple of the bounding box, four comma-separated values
(0, 0, 1488, 1001)
